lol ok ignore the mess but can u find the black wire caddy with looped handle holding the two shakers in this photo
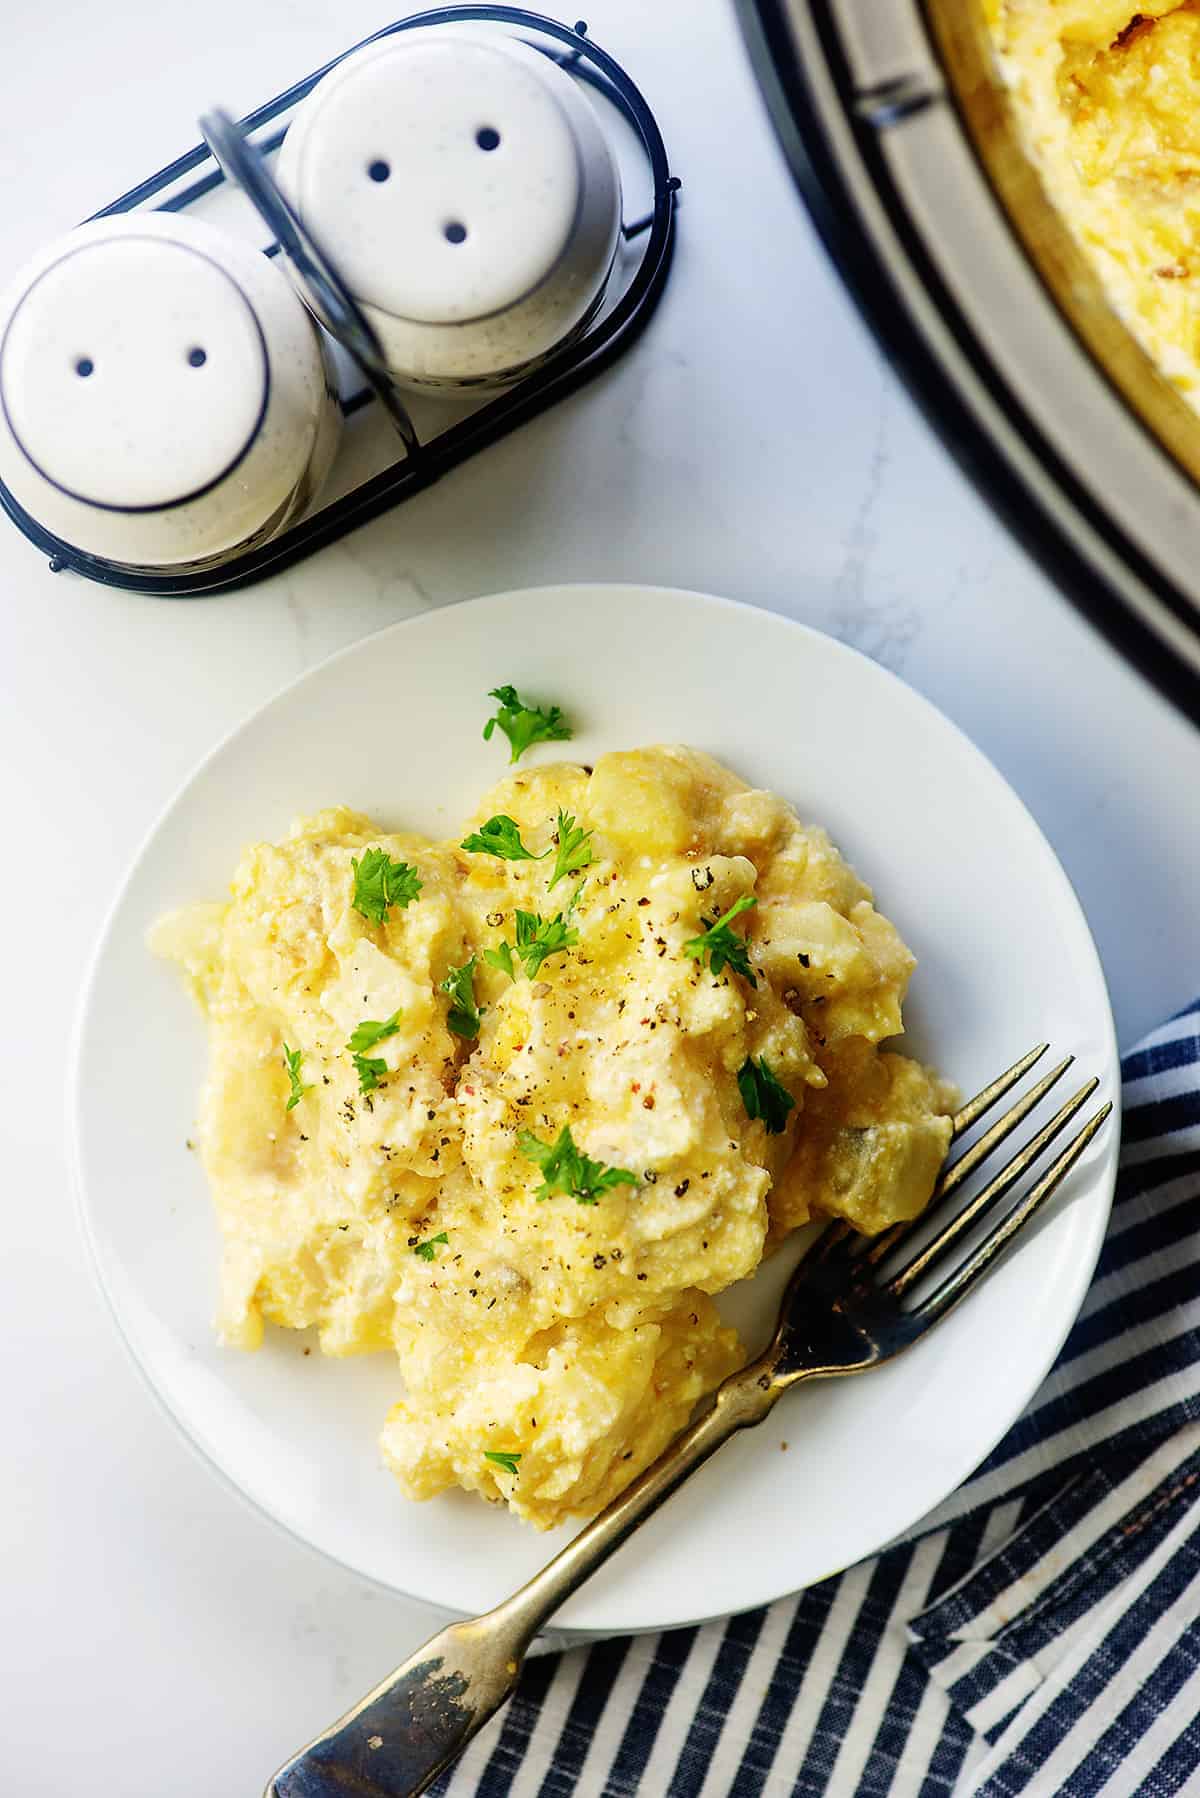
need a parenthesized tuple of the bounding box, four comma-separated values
(0, 5, 680, 599)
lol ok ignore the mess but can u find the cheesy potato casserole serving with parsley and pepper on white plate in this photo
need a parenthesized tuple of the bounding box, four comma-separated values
(155, 740, 950, 1527)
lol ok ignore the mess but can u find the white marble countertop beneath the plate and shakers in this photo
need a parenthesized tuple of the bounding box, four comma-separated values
(0, 0, 1200, 1798)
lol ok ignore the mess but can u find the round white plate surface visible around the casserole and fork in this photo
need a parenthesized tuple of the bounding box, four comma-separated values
(76, 586, 1119, 1631)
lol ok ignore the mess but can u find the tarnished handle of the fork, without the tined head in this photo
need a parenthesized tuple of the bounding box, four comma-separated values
(266, 1343, 784, 1798)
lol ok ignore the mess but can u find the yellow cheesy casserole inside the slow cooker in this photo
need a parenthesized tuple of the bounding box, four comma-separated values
(984, 0, 1200, 403)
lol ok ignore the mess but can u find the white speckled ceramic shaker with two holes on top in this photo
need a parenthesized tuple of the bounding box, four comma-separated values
(0, 212, 340, 572)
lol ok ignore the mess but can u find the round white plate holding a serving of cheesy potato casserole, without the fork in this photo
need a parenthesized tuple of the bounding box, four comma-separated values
(72, 577, 1119, 1633)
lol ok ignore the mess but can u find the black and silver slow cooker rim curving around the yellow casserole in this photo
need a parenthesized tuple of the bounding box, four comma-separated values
(738, 0, 1200, 723)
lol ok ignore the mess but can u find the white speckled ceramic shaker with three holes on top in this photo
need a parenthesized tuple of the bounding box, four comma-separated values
(277, 25, 621, 387)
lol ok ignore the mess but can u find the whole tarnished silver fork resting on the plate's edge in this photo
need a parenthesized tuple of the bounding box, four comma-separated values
(266, 1043, 1112, 1798)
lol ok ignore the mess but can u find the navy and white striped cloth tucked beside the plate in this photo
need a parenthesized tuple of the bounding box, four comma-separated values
(435, 1001, 1200, 1798)
